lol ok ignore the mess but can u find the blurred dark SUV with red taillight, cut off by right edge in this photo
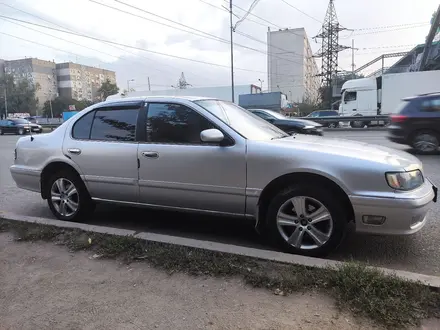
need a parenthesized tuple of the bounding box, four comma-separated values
(388, 93, 440, 154)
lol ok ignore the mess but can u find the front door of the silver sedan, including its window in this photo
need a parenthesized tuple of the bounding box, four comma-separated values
(138, 102, 246, 215)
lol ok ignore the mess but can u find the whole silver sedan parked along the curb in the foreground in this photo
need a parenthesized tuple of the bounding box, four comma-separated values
(10, 97, 437, 256)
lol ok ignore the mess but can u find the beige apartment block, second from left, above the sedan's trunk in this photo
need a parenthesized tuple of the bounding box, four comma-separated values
(56, 62, 116, 101)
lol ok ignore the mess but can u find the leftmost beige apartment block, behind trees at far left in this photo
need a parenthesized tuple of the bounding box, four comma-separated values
(4, 58, 58, 109)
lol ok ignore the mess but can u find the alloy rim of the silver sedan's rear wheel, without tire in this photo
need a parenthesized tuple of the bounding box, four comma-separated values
(50, 178, 79, 217)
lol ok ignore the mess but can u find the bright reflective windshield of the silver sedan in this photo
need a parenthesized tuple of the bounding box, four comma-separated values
(194, 100, 289, 140)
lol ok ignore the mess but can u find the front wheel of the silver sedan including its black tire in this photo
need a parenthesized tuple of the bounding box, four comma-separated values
(266, 184, 348, 257)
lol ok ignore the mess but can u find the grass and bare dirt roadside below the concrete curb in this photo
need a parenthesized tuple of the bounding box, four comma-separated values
(0, 219, 440, 329)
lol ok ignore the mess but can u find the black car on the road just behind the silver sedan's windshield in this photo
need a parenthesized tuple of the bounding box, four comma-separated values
(249, 109, 323, 135)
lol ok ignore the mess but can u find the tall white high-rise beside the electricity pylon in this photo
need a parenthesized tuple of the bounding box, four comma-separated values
(267, 28, 320, 103)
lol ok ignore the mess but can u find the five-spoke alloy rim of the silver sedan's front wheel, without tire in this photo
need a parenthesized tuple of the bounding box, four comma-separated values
(276, 196, 333, 250)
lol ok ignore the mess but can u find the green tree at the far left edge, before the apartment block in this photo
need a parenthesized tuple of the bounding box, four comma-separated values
(0, 74, 39, 115)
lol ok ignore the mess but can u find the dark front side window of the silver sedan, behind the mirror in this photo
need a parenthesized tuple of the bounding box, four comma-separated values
(146, 103, 216, 144)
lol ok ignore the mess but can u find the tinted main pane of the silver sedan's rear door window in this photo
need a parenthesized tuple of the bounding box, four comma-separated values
(90, 109, 139, 141)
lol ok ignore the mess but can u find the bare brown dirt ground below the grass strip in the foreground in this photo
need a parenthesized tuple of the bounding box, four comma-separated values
(0, 233, 378, 330)
